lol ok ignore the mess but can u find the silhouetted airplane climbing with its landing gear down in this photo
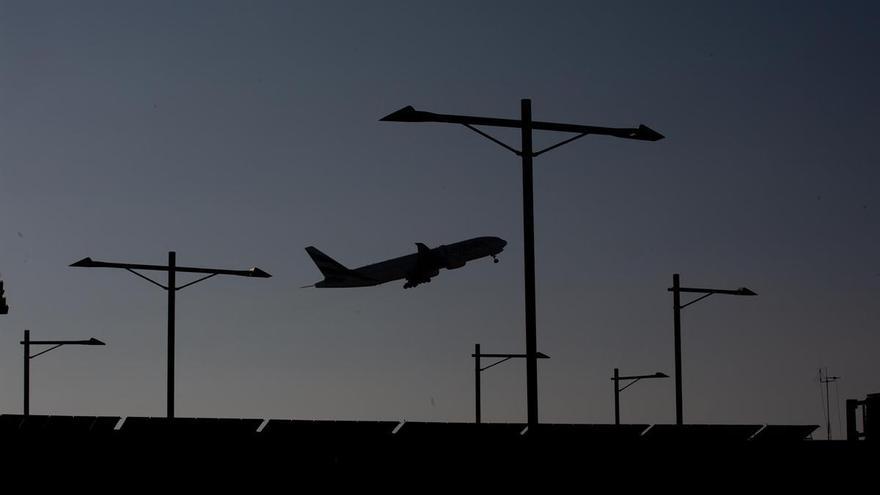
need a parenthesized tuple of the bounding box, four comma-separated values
(306, 237, 507, 289)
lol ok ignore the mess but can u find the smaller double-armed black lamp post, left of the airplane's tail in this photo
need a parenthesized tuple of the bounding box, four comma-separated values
(70, 251, 271, 418)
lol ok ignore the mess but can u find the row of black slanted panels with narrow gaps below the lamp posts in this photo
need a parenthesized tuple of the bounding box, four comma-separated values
(0, 414, 818, 443)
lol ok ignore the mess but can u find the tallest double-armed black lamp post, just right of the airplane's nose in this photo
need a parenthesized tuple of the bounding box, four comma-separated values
(380, 99, 663, 426)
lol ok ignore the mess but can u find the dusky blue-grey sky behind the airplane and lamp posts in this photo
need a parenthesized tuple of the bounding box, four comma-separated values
(0, 0, 880, 437)
